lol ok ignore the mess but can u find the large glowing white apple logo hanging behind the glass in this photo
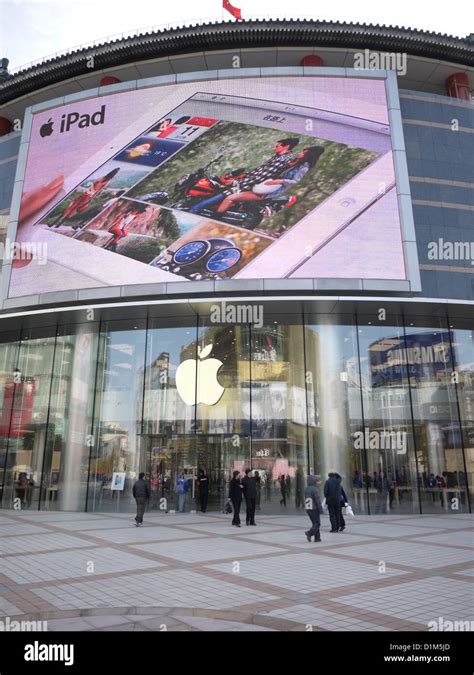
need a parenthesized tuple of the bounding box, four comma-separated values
(176, 343, 224, 405)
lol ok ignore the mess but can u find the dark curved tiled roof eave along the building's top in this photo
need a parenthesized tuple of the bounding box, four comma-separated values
(0, 20, 474, 104)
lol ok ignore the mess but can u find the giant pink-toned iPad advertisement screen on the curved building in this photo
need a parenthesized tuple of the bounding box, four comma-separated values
(9, 76, 407, 297)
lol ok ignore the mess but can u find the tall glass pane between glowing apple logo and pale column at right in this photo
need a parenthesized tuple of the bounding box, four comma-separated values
(241, 312, 308, 513)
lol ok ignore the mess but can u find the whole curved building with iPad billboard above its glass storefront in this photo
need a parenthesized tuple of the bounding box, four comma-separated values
(0, 22, 474, 514)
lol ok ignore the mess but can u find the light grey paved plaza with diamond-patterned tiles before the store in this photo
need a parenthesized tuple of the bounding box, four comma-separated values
(0, 511, 474, 631)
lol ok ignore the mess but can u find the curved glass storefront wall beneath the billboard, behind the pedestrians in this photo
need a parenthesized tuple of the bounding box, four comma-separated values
(0, 303, 474, 514)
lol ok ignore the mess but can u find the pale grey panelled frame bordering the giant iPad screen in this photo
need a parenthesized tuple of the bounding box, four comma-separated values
(0, 67, 422, 311)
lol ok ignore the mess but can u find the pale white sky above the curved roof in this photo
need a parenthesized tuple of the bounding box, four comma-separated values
(0, 0, 474, 71)
